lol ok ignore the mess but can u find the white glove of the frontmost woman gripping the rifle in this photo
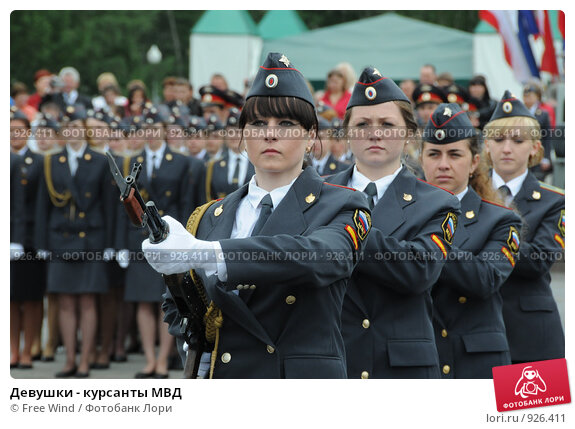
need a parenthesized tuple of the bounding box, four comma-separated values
(142, 216, 221, 274)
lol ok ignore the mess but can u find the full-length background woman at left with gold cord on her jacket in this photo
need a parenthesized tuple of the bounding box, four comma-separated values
(35, 106, 115, 377)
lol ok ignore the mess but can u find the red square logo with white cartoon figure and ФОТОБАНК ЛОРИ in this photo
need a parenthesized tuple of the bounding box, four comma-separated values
(493, 359, 571, 411)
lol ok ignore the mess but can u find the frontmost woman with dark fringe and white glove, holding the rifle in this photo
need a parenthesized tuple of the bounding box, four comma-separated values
(142, 53, 369, 378)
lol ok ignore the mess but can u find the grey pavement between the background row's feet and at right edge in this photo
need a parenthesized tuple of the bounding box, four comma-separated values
(10, 262, 565, 379)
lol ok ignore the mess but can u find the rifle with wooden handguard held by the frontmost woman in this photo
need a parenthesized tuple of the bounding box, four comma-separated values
(106, 151, 208, 378)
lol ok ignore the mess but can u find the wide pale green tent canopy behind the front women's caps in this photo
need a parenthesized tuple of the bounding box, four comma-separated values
(262, 13, 473, 81)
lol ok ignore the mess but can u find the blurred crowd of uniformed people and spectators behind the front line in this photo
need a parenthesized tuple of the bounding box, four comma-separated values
(10, 63, 556, 378)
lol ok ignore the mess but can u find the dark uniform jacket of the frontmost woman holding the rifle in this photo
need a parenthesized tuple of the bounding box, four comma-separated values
(164, 167, 369, 378)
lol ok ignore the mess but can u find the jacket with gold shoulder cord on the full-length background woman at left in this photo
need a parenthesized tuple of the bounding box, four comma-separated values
(35, 147, 116, 254)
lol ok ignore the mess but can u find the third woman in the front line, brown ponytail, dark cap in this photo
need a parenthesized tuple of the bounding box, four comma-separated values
(421, 103, 521, 378)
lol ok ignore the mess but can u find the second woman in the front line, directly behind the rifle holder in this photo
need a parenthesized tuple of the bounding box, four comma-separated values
(328, 67, 459, 378)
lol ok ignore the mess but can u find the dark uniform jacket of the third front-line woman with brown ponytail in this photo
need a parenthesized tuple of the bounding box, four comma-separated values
(431, 188, 521, 378)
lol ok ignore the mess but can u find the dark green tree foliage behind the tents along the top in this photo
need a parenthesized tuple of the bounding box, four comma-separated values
(10, 10, 477, 94)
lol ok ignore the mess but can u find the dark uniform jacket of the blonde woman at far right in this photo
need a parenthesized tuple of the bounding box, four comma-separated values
(501, 173, 565, 362)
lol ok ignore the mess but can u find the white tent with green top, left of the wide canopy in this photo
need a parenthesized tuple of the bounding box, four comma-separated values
(190, 10, 262, 93)
